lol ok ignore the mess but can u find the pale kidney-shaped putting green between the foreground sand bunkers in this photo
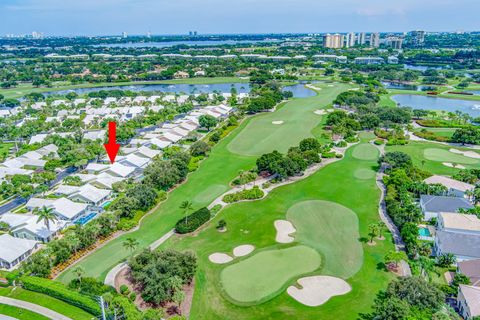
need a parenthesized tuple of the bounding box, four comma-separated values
(220, 245, 321, 305)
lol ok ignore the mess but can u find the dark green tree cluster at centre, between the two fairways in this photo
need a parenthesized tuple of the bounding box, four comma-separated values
(256, 138, 324, 180)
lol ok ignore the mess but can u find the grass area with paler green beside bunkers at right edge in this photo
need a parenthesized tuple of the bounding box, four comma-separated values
(385, 141, 480, 176)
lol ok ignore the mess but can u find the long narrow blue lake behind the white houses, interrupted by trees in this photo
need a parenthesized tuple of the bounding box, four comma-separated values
(43, 82, 315, 98)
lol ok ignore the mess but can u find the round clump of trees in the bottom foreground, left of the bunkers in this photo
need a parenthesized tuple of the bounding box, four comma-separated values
(128, 249, 197, 306)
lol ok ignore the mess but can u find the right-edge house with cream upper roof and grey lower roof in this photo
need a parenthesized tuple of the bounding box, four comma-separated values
(433, 212, 480, 262)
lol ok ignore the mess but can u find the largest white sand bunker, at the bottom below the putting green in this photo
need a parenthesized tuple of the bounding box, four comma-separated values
(287, 276, 352, 307)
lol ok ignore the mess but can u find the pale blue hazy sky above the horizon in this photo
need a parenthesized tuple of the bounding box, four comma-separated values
(0, 0, 480, 36)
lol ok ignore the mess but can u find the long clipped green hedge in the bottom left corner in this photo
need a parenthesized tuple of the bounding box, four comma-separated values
(20, 276, 101, 316)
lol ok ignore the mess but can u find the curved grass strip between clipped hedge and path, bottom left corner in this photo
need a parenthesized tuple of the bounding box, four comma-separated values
(0, 287, 94, 320)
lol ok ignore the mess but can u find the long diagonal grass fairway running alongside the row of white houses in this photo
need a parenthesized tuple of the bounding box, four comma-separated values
(58, 85, 346, 283)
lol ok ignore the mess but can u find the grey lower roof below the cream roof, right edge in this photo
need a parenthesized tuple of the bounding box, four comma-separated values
(436, 230, 480, 258)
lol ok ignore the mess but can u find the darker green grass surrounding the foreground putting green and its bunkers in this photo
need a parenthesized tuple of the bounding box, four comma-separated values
(161, 136, 393, 320)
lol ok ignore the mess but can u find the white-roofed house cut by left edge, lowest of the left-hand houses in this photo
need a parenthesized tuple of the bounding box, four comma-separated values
(0, 234, 39, 270)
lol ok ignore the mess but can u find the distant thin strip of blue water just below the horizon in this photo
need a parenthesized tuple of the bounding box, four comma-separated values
(95, 39, 280, 48)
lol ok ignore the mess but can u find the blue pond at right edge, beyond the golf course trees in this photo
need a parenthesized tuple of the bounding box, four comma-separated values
(392, 94, 480, 117)
